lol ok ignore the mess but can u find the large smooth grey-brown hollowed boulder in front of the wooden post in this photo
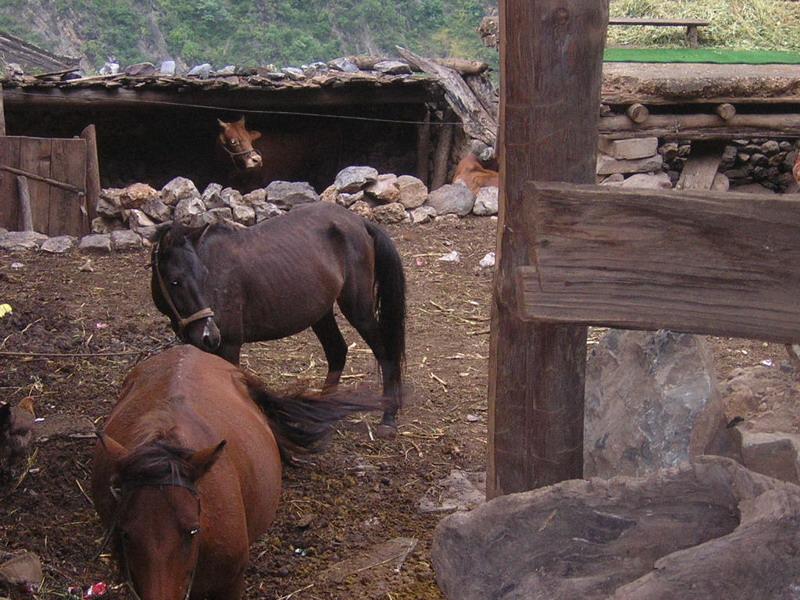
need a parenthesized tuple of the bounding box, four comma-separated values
(431, 457, 800, 600)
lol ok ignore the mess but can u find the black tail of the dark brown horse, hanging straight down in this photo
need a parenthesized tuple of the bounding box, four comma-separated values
(365, 221, 406, 372)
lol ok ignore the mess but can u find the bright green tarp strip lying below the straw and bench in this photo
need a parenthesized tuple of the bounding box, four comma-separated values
(603, 48, 800, 65)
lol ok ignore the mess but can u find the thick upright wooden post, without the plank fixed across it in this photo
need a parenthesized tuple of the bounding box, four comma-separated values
(486, 0, 608, 498)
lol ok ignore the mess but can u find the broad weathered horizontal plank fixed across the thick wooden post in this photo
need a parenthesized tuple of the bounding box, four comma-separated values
(517, 182, 800, 343)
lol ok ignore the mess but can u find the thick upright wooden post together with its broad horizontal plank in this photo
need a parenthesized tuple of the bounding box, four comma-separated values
(487, 0, 800, 497)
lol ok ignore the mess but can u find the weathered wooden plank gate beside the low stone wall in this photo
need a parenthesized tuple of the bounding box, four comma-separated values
(0, 125, 100, 237)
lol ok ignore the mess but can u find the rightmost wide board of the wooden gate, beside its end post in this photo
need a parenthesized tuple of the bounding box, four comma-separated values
(48, 139, 86, 237)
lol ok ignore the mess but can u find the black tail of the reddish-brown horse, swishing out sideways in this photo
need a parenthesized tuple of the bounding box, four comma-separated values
(245, 374, 383, 464)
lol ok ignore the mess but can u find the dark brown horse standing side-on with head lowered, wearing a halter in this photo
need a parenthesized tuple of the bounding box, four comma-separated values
(151, 202, 405, 433)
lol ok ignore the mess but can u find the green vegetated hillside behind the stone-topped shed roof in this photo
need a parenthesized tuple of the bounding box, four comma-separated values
(0, 0, 497, 71)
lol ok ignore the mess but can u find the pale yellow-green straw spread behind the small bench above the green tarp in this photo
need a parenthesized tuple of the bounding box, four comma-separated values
(608, 0, 800, 52)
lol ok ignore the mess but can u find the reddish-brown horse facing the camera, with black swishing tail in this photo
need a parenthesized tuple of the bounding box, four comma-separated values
(92, 346, 376, 600)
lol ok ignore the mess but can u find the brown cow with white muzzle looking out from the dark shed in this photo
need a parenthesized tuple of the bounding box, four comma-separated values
(216, 117, 341, 193)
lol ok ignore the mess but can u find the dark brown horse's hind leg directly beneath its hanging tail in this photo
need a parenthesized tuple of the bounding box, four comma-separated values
(339, 286, 401, 437)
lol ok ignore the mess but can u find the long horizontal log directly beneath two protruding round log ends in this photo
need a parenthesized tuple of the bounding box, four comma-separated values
(599, 113, 800, 139)
